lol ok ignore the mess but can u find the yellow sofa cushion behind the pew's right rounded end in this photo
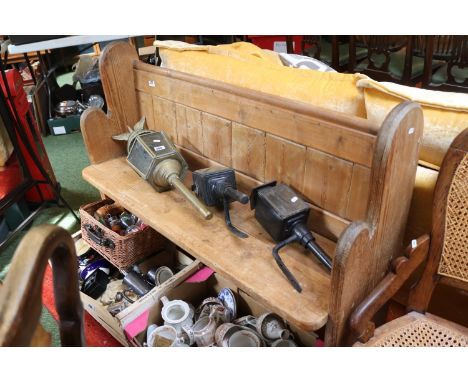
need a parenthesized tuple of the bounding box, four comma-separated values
(357, 79, 468, 166)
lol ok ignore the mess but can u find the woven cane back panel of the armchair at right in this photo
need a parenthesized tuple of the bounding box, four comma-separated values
(438, 154, 468, 282)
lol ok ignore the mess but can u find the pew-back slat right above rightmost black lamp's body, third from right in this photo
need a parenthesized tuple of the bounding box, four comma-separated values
(265, 134, 306, 193)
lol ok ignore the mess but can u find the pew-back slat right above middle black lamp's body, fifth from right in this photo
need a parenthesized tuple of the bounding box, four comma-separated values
(202, 113, 232, 166)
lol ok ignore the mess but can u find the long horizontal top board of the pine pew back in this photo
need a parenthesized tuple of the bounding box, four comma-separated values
(135, 70, 375, 167)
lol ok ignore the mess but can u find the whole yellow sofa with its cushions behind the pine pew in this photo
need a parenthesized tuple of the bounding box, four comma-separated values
(155, 41, 458, 241)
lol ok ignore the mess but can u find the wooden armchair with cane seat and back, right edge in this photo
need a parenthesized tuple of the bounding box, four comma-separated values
(350, 129, 468, 346)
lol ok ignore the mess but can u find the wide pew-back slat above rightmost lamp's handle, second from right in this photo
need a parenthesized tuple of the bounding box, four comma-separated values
(303, 148, 353, 217)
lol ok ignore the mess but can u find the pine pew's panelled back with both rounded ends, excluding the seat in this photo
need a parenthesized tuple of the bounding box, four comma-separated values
(81, 43, 422, 345)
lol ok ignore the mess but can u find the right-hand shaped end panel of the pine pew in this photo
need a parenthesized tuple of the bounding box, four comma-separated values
(325, 102, 423, 345)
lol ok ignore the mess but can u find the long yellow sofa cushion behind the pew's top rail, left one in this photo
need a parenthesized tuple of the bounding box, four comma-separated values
(155, 41, 367, 118)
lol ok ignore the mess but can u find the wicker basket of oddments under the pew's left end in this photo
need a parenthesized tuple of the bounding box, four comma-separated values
(80, 199, 165, 269)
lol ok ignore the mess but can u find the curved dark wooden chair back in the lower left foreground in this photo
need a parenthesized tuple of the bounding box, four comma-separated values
(0, 225, 85, 346)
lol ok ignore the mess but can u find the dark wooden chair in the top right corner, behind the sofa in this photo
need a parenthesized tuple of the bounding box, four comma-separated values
(417, 36, 468, 92)
